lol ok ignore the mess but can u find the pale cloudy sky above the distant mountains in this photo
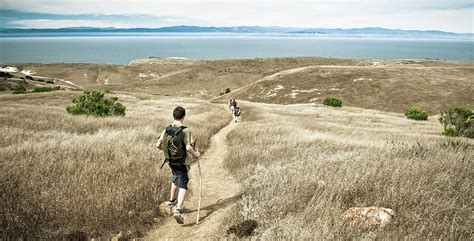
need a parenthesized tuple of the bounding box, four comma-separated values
(0, 0, 474, 33)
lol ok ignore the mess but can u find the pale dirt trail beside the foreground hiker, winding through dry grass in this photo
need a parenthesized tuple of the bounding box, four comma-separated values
(145, 117, 241, 240)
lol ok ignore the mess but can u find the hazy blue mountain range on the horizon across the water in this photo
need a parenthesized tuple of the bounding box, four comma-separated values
(0, 25, 474, 37)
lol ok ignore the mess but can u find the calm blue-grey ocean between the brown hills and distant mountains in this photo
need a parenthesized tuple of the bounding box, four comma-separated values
(0, 33, 474, 64)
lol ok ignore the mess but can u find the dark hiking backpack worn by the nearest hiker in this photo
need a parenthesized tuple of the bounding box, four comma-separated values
(163, 125, 187, 165)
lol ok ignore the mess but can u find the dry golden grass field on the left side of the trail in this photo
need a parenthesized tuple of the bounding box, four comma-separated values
(0, 91, 230, 239)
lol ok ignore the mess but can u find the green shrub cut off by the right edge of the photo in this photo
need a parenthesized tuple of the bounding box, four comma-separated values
(438, 107, 474, 138)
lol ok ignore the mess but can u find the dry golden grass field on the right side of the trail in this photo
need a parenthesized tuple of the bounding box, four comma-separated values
(224, 102, 474, 240)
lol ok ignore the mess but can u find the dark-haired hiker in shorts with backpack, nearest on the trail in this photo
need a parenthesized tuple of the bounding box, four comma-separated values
(156, 106, 201, 224)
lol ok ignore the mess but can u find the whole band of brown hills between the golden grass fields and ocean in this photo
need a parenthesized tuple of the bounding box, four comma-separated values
(5, 57, 474, 114)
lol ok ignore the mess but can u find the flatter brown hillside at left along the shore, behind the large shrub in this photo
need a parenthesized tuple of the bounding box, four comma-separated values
(6, 57, 365, 99)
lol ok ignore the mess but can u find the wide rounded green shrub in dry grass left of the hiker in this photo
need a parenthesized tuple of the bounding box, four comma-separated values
(66, 91, 126, 117)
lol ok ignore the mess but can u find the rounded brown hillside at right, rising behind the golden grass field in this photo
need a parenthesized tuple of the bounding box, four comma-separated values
(223, 62, 474, 114)
